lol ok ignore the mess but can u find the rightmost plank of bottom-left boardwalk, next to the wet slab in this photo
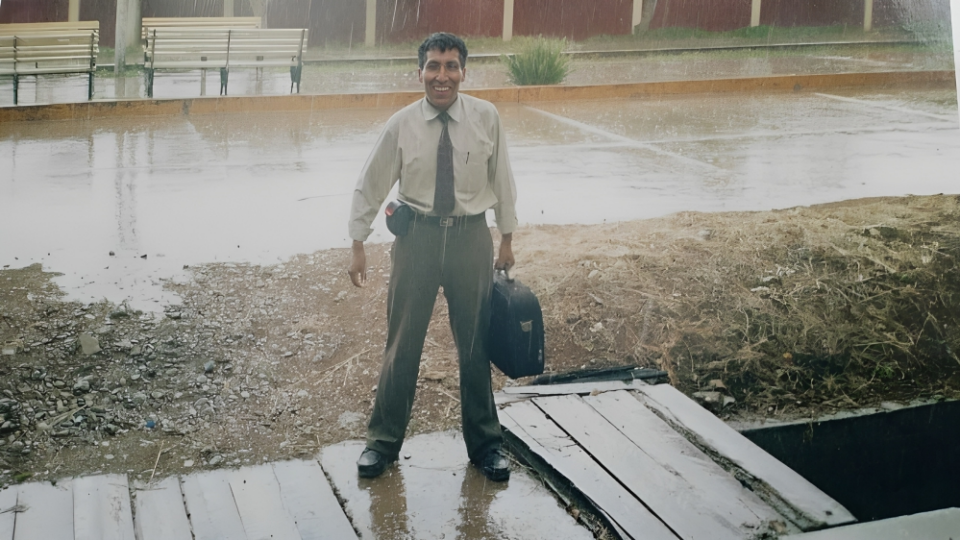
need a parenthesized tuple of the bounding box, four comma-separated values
(273, 461, 357, 540)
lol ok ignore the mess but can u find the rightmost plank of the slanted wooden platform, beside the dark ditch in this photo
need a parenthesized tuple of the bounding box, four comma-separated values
(637, 384, 856, 531)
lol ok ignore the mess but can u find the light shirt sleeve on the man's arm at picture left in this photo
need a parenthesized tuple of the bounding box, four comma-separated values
(349, 118, 402, 242)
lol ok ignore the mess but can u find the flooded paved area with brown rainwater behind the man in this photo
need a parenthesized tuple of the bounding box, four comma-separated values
(0, 88, 960, 311)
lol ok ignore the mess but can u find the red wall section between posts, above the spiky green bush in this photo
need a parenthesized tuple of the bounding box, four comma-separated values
(512, 0, 633, 40)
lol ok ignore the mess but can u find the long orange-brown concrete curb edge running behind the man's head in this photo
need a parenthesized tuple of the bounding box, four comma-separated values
(0, 70, 956, 122)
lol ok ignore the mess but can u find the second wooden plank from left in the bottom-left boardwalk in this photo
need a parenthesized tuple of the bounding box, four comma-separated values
(13, 480, 73, 540)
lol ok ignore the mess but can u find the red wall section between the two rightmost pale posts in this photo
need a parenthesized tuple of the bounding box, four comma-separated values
(760, 0, 863, 26)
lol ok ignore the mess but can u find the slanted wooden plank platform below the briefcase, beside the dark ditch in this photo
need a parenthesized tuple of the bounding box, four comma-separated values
(497, 381, 855, 540)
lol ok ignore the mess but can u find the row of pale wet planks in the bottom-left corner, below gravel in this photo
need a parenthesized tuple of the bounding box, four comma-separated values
(0, 461, 357, 540)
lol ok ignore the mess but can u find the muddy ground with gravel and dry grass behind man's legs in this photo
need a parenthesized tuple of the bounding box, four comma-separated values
(0, 195, 960, 486)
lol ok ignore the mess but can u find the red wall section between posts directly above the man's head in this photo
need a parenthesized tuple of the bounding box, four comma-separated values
(377, 0, 503, 43)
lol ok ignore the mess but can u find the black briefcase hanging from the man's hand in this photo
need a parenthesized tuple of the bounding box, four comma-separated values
(487, 271, 544, 379)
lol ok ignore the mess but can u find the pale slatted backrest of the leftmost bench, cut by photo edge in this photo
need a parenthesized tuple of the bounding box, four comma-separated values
(0, 30, 99, 75)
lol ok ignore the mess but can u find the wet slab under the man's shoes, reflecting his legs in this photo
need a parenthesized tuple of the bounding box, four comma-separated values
(321, 432, 593, 540)
